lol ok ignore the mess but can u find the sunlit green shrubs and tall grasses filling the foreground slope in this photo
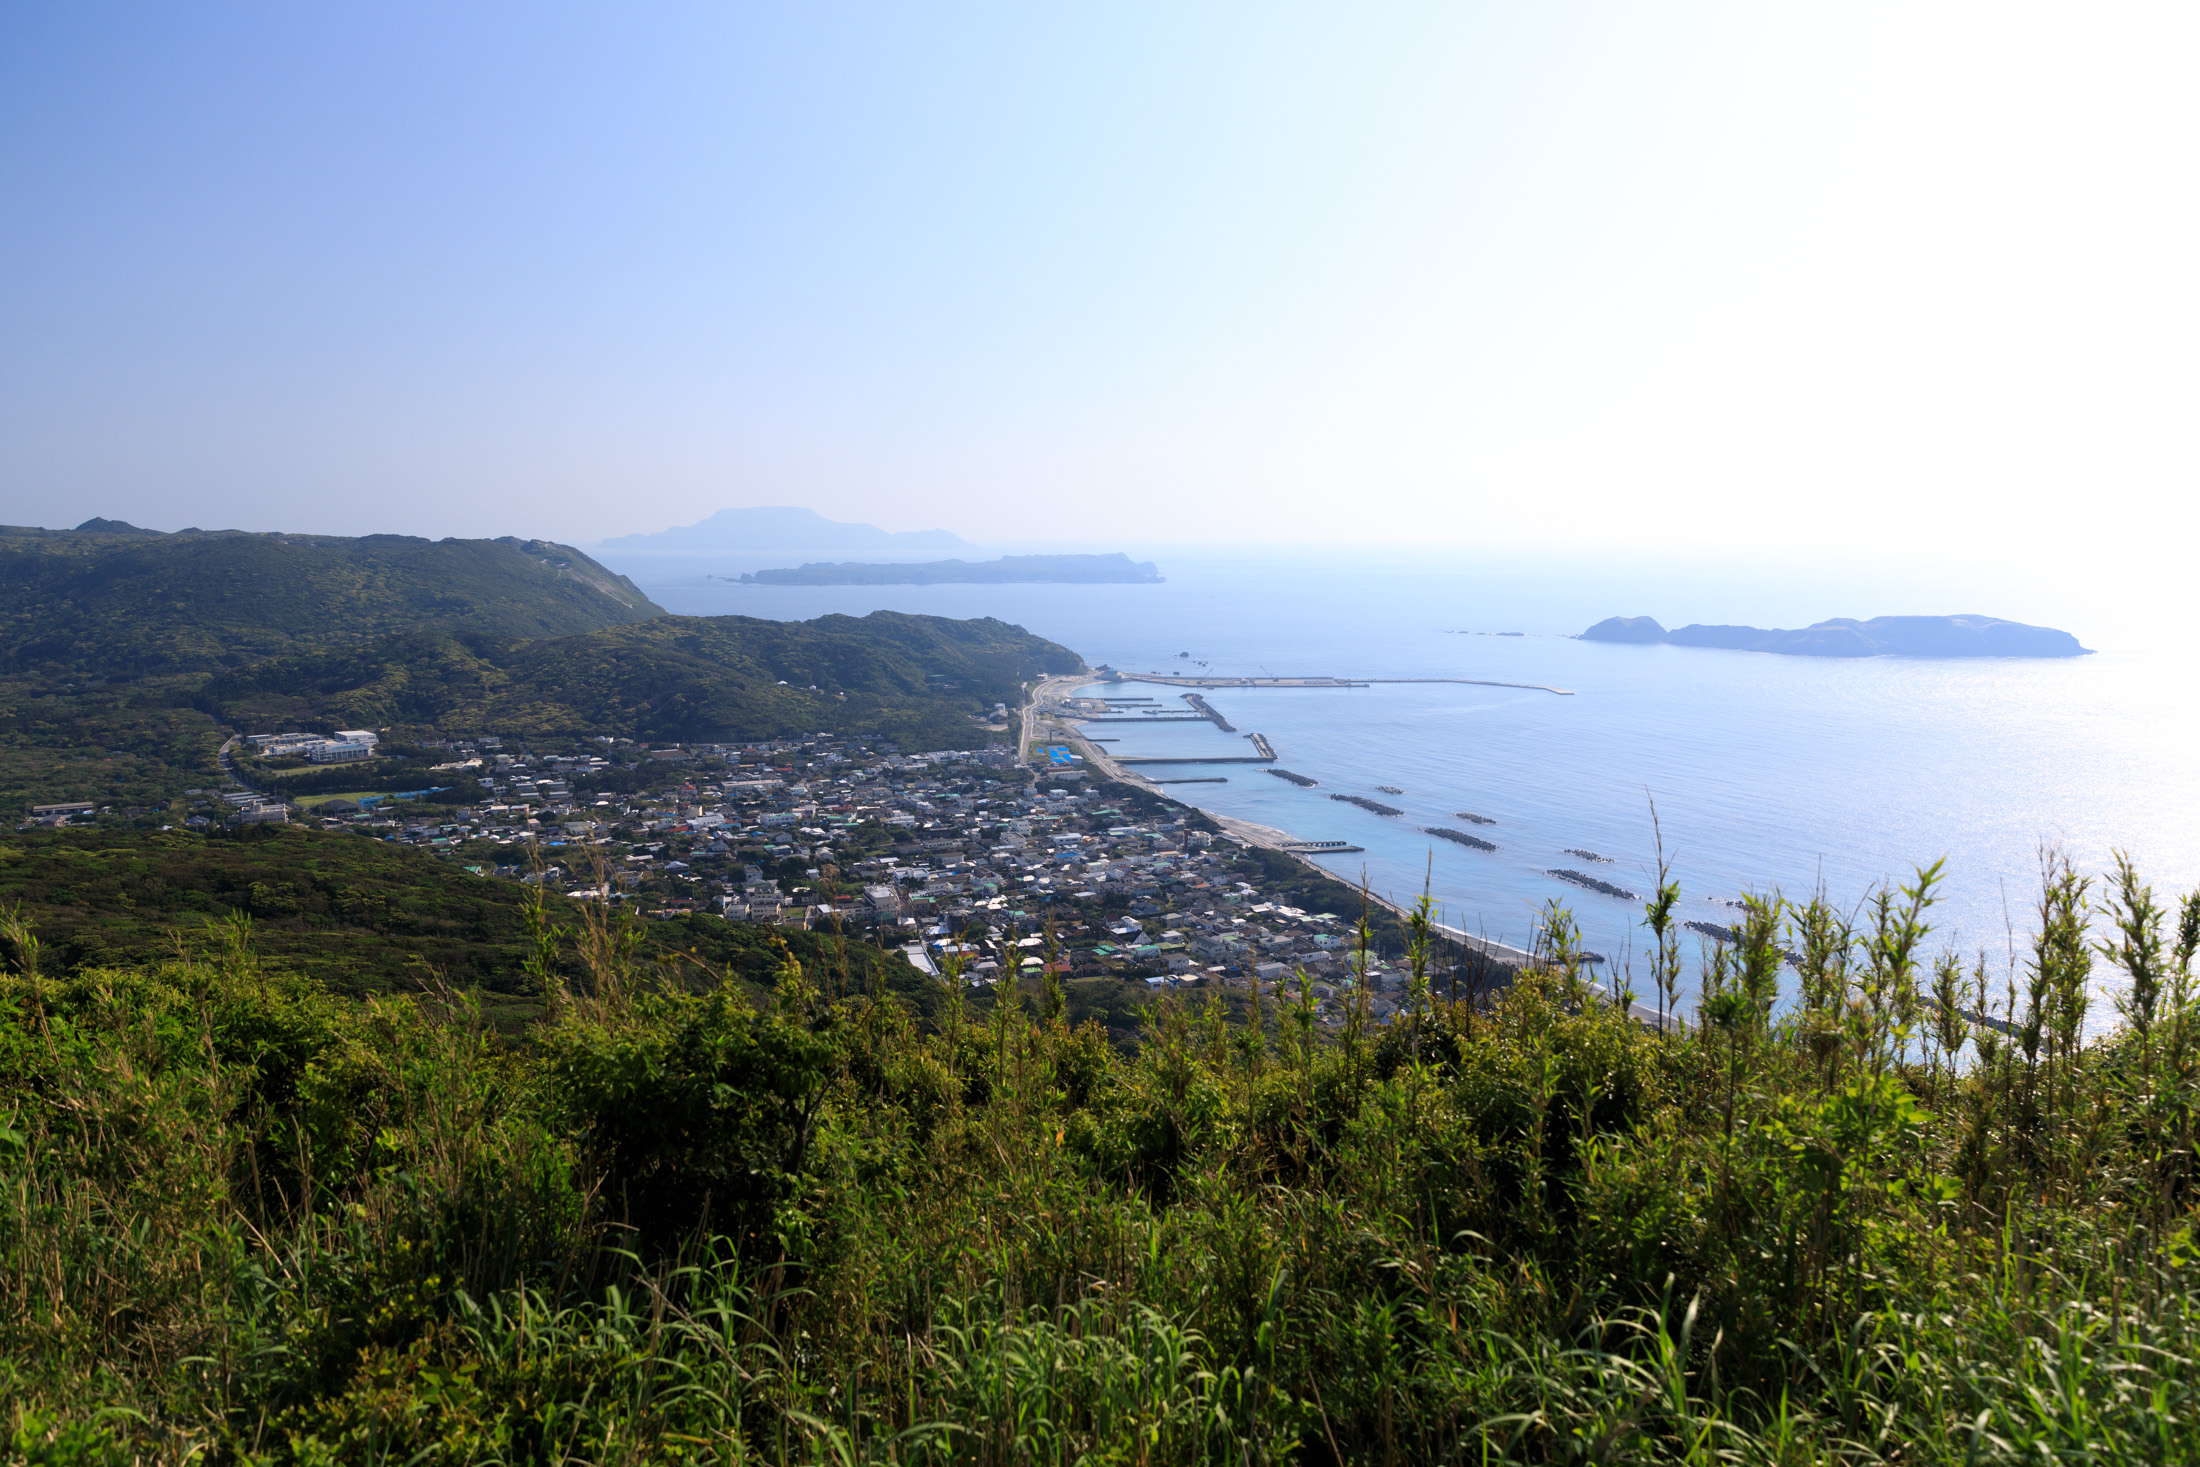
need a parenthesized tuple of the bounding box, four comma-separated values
(0, 864, 2200, 1463)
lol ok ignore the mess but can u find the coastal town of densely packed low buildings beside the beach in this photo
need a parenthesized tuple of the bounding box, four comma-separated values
(33, 710, 1496, 1027)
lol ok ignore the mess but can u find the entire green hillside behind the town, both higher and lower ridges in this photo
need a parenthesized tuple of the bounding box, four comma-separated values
(0, 519, 1078, 818)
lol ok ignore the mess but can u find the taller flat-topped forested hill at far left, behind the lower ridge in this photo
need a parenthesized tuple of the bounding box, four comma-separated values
(0, 519, 662, 677)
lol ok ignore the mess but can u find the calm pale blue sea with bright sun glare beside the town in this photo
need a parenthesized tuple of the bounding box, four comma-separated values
(605, 545, 2200, 1018)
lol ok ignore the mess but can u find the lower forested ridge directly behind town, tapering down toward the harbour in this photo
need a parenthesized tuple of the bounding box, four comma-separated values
(200, 611, 1082, 748)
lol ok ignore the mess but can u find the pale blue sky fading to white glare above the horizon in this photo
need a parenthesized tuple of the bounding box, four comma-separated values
(0, 2, 2200, 598)
